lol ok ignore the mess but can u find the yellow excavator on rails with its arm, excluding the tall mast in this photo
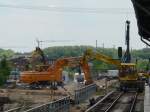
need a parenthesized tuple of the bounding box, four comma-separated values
(84, 49, 144, 92)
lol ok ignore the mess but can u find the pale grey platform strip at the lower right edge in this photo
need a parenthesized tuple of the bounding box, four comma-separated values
(144, 86, 150, 112)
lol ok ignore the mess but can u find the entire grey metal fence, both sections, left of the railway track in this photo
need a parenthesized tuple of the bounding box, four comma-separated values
(19, 84, 97, 112)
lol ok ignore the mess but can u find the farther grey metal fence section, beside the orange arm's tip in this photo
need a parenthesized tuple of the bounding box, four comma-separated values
(74, 84, 97, 104)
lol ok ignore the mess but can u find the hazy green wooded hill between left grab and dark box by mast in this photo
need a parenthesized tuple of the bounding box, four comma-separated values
(44, 46, 117, 59)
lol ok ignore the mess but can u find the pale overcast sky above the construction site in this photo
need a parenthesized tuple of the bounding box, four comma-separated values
(0, 0, 145, 52)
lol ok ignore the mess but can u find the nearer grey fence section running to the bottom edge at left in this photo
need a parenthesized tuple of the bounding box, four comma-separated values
(24, 96, 70, 112)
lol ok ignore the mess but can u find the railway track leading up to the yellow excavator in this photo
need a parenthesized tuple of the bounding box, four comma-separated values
(86, 92, 138, 112)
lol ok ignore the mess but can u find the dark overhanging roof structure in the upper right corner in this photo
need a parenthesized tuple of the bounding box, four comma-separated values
(131, 0, 150, 46)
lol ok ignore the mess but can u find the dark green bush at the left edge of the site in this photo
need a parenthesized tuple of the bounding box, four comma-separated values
(0, 56, 10, 85)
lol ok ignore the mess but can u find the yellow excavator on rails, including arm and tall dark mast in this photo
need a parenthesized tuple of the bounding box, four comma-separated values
(84, 20, 145, 92)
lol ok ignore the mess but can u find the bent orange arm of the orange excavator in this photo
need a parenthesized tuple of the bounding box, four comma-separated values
(48, 57, 93, 84)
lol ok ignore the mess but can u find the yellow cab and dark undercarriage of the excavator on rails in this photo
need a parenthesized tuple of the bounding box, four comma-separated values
(119, 63, 144, 92)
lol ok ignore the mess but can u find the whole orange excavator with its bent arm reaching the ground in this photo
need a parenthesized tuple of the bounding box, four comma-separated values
(20, 57, 93, 86)
